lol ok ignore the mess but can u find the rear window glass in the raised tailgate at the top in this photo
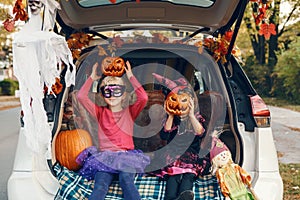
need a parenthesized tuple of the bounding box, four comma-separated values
(77, 0, 215, 7)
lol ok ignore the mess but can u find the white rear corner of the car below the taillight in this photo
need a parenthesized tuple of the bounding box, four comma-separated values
(239, 124, 283, 200)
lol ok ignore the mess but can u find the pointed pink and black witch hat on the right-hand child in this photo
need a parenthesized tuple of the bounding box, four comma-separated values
(152, 73, 189, 93)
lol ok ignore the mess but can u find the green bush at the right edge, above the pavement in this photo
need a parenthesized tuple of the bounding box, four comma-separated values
(272, 36, 300, 103)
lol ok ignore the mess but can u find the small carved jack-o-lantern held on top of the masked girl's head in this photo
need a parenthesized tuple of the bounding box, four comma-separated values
(101, 56, 125, 77)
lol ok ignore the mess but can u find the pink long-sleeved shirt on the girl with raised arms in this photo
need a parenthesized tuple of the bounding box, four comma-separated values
(77, 76, 148, 151)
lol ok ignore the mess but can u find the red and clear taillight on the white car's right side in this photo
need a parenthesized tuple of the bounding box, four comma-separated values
(250, 95, 271, 127)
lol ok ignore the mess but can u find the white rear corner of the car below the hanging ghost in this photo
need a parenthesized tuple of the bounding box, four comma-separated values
(7, 128, 59, 200)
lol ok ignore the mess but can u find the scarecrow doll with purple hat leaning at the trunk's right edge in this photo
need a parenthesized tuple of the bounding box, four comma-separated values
(210, 137, 258, 200)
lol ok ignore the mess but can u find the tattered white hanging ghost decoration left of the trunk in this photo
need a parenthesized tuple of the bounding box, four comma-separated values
(13, 0, 76, 158)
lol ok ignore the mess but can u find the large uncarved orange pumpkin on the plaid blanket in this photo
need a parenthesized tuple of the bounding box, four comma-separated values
(55, 129, 92, 171)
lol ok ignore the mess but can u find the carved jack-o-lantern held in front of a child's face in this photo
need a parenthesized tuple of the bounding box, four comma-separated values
(165, 92, 190, 115)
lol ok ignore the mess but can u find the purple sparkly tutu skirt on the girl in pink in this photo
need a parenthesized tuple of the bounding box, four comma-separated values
(76, 146, 150, 180)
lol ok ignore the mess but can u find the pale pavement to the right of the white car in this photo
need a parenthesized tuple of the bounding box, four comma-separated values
(269, 106, 300, 163)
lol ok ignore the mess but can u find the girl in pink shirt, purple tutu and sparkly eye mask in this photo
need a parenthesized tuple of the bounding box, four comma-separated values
(76, 61, 150, 200)
